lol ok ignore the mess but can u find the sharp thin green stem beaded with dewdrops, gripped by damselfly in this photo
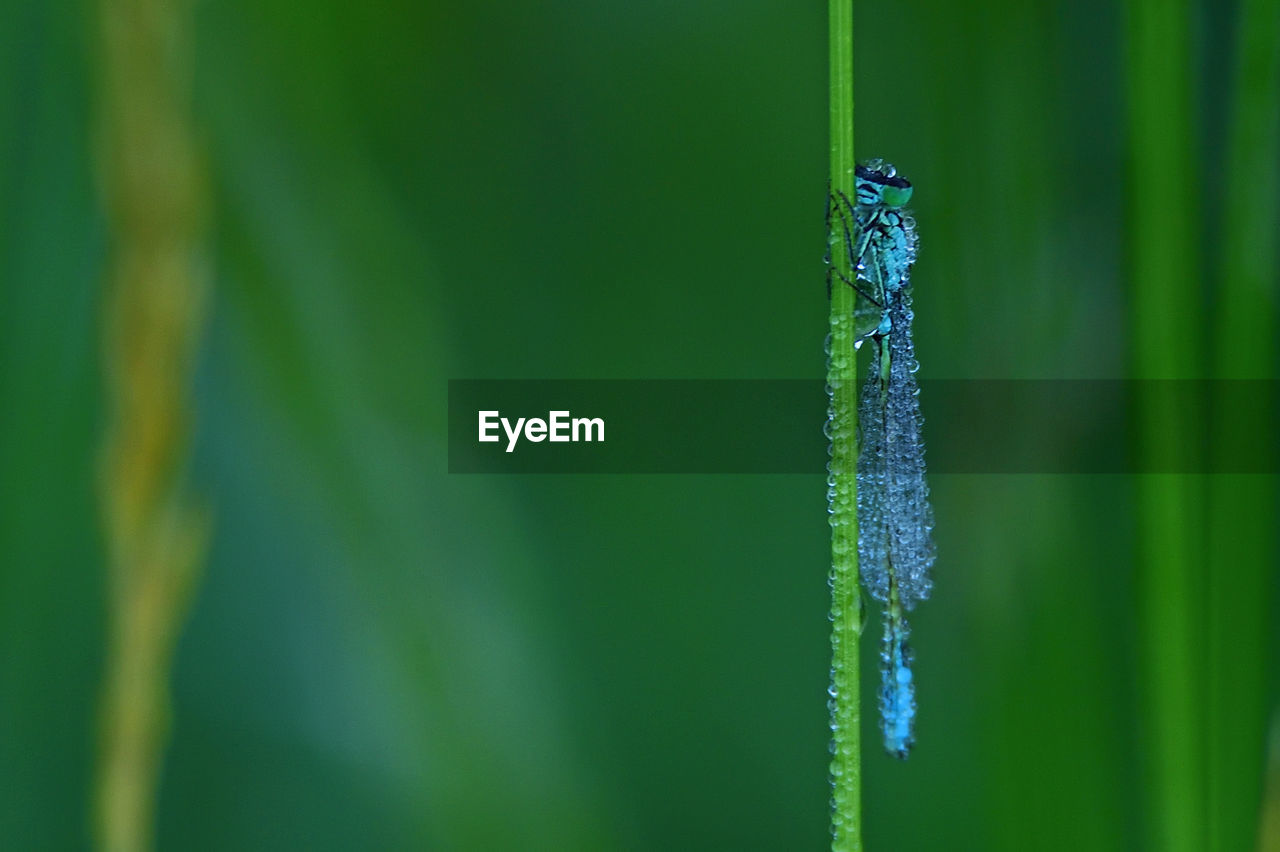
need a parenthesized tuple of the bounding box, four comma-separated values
(827, 0, 863, 852)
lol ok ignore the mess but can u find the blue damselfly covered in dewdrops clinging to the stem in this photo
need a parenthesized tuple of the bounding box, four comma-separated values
(827, 160, 934, 757)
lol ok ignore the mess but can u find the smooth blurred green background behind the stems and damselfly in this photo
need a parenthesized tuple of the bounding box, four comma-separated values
(0, 0, 1280, 851)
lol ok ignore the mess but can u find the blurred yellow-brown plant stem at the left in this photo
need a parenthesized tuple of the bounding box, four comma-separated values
(95, 0, 207, 852)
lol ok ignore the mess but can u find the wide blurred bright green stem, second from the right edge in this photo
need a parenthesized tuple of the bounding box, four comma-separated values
(1126, 0, 1207, 852)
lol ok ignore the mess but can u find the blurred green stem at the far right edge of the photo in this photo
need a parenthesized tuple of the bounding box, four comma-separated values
(1206, 0, 1280, 852)
